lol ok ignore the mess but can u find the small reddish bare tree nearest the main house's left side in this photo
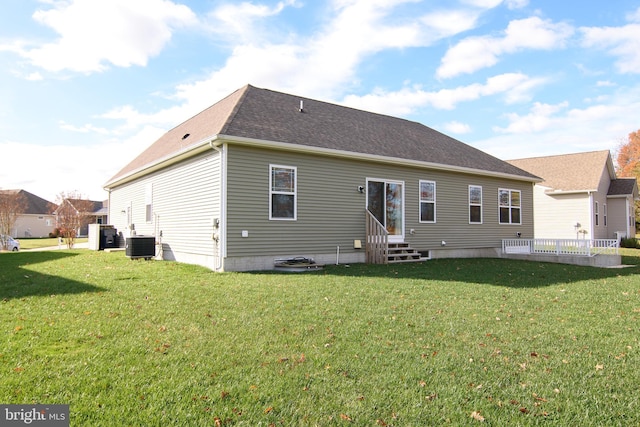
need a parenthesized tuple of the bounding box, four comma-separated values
(55, 192, 93, 249)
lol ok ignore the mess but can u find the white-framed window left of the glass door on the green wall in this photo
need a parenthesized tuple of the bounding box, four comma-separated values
(269, 165, 296, 220)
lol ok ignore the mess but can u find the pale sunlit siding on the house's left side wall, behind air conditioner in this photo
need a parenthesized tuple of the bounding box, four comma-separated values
(110, 151, 220, 258)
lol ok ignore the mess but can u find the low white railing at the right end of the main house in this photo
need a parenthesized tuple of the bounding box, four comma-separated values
(502, 239, 618, 256)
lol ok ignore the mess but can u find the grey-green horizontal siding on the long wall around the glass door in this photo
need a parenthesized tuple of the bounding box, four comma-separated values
(226, 146, 533, 257)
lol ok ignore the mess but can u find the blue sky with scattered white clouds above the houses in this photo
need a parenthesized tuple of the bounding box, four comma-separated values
(0, 0, 640, 202)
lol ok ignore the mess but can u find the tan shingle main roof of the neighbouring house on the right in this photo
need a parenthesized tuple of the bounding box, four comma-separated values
(507, 150, 615, 191)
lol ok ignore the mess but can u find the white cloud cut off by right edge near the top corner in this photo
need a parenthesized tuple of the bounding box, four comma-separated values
(580, 20, 640, 73)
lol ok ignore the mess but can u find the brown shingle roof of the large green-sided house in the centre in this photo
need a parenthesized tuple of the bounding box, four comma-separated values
(107, 85, 537, 185)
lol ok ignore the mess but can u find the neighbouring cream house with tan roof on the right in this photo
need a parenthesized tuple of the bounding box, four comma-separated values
(508, 150, 638, 239)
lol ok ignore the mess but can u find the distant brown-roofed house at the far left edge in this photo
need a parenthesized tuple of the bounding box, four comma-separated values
(0, 190, 57, 238)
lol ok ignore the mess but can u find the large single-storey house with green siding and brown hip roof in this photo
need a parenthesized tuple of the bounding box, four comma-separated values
(105, 85, 539, 271)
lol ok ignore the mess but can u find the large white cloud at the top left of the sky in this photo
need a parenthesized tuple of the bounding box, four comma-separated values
(20, 0, 196, 73)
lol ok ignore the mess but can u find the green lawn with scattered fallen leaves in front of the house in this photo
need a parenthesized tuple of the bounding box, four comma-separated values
(0, 250, 640, 426)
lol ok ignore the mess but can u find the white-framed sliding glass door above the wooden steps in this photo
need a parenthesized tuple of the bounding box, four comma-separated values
(367, 179, 404, 243)
